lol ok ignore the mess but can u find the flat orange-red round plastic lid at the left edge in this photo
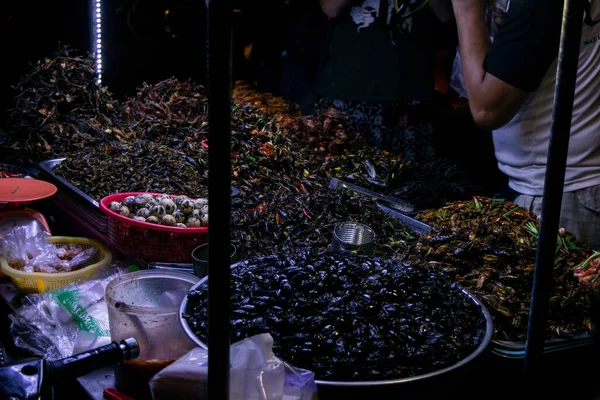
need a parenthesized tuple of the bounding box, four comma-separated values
(0, 178, 57, 205)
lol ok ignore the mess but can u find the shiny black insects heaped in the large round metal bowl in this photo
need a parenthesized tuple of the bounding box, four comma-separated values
(184, 252, 485, 381)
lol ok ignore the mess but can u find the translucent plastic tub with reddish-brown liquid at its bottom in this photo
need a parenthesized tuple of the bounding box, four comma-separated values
(105, 270, 198, 399)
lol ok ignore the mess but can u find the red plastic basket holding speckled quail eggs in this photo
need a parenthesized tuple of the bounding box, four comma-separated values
(100, 192, 208, 262)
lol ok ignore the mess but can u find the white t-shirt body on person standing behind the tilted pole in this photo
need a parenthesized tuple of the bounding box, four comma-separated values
(493, 0, 600, 196)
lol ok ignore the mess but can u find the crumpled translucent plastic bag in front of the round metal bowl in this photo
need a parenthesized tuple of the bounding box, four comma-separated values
(150, 333, 317, 400)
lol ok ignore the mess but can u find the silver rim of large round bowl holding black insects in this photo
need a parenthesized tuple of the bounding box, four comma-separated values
(179, 261, 494, 388)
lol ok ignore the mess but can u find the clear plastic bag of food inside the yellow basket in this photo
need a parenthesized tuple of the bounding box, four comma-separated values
(0, 226, 98, 273)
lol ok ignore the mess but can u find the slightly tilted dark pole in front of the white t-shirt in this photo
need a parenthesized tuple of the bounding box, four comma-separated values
(525, 0, 586, 384)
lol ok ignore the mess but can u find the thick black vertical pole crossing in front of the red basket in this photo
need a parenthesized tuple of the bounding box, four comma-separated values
(207, 0, 232, 400)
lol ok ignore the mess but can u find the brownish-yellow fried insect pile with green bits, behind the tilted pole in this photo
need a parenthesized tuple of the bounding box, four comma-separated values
(417, 197, 592, 341)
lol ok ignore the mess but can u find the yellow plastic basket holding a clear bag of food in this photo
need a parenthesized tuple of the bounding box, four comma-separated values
(0, 236, 112, 294)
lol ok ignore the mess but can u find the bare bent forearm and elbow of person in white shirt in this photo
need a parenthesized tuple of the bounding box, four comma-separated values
(452, 0, 527, 129)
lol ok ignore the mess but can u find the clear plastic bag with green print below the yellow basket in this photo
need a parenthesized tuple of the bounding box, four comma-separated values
(9, 263, 126, 361)
